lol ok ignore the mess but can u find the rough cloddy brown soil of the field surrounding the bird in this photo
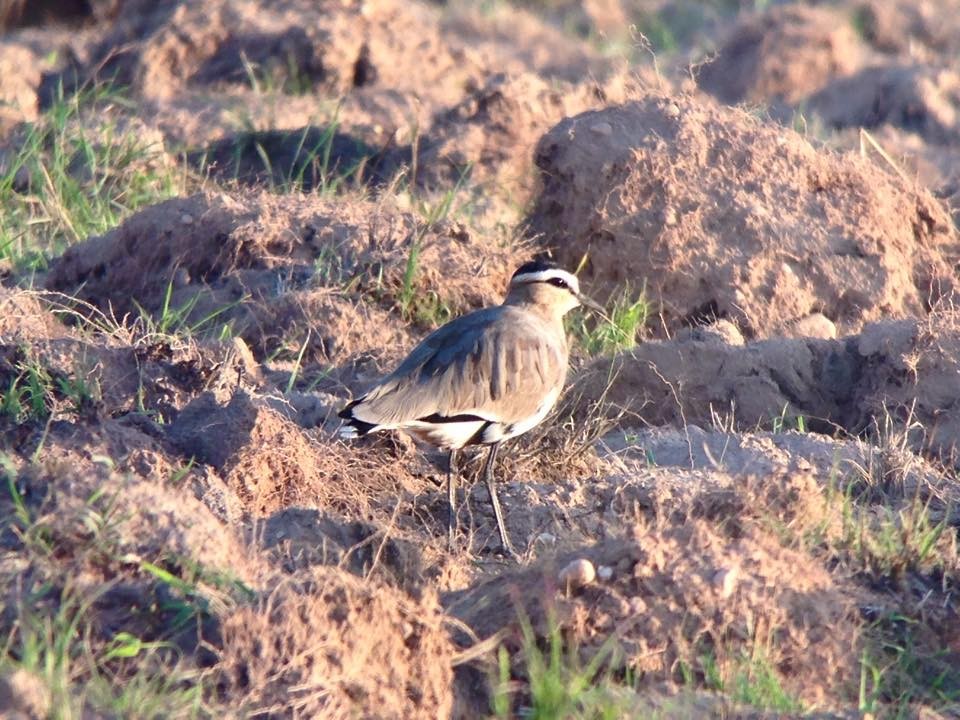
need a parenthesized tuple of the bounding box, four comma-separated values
(0, 0, 960, 719)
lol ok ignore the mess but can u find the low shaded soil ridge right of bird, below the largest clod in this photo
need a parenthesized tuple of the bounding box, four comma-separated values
(584, 313, 960, 463)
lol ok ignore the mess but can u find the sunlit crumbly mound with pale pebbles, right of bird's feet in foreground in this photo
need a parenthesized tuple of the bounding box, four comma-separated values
(446, 518, 859, 703)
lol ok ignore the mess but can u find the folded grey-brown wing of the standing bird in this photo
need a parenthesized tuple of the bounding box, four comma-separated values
(351, 307, 567, 427)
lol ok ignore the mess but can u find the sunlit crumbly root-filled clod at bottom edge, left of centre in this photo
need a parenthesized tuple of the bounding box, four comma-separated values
(218, 568, 453, 720)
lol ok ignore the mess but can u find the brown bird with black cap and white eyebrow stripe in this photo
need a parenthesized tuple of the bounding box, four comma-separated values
(338, 259, 603, 557)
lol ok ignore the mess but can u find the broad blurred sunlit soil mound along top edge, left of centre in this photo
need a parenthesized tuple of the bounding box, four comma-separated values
(47, 0, 477, 105)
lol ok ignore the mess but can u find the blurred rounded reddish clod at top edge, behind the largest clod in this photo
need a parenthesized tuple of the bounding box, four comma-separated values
(697, 4, 862, 105)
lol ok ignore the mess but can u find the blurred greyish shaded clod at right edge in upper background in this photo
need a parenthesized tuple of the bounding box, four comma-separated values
(809, 64, 960, 145)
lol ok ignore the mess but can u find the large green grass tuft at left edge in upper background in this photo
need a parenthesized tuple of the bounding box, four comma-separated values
(0, 82, 187, 273)
